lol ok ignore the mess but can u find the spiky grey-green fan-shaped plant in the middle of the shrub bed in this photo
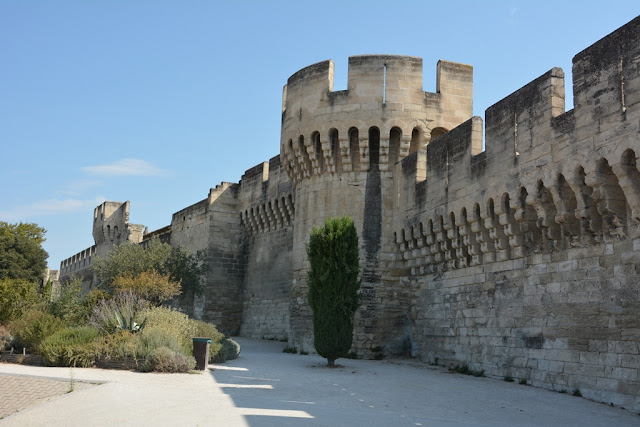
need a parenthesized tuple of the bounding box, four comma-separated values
(89, 292, 149, 334)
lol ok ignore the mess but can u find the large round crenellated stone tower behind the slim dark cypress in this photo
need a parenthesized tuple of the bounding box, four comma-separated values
(280, 55, 473, 353)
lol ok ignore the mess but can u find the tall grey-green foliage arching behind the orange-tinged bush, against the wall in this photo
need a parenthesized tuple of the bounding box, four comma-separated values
(93, 238, 207, 294)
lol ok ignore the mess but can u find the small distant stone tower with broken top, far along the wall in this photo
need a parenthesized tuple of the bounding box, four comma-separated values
(93, 201, 144, 256)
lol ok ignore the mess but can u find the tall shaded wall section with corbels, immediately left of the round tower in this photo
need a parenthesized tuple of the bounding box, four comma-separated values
(239, 157, 296, 339)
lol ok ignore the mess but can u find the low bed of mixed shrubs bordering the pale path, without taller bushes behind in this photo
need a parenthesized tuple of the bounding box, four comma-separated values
(0, 291, 240, 372)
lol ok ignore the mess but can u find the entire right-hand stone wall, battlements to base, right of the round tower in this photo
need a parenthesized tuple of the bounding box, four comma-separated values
(393, 18, 640, 410)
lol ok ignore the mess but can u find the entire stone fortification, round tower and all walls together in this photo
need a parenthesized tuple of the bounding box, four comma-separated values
(61, 18, 640, 411)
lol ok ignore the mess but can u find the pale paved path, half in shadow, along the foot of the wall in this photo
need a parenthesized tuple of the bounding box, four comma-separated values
(0, 338, 640, 426)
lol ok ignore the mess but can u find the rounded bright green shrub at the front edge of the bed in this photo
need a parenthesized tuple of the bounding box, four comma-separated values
(40, 326, 99, 367)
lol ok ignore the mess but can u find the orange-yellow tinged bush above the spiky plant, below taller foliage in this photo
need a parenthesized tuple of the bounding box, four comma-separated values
(113, 270, 181, 305)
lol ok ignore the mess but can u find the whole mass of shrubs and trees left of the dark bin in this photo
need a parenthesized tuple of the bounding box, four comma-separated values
(0, 227, 240, 372)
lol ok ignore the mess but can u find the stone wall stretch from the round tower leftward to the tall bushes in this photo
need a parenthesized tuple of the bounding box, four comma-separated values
(169, 157, 295, 339)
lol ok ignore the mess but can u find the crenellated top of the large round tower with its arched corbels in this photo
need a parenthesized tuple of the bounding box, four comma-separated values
(280, 55, 473, 185)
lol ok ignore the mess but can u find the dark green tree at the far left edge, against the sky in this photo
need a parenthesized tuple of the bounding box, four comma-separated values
(0, 221, 49, 283)
